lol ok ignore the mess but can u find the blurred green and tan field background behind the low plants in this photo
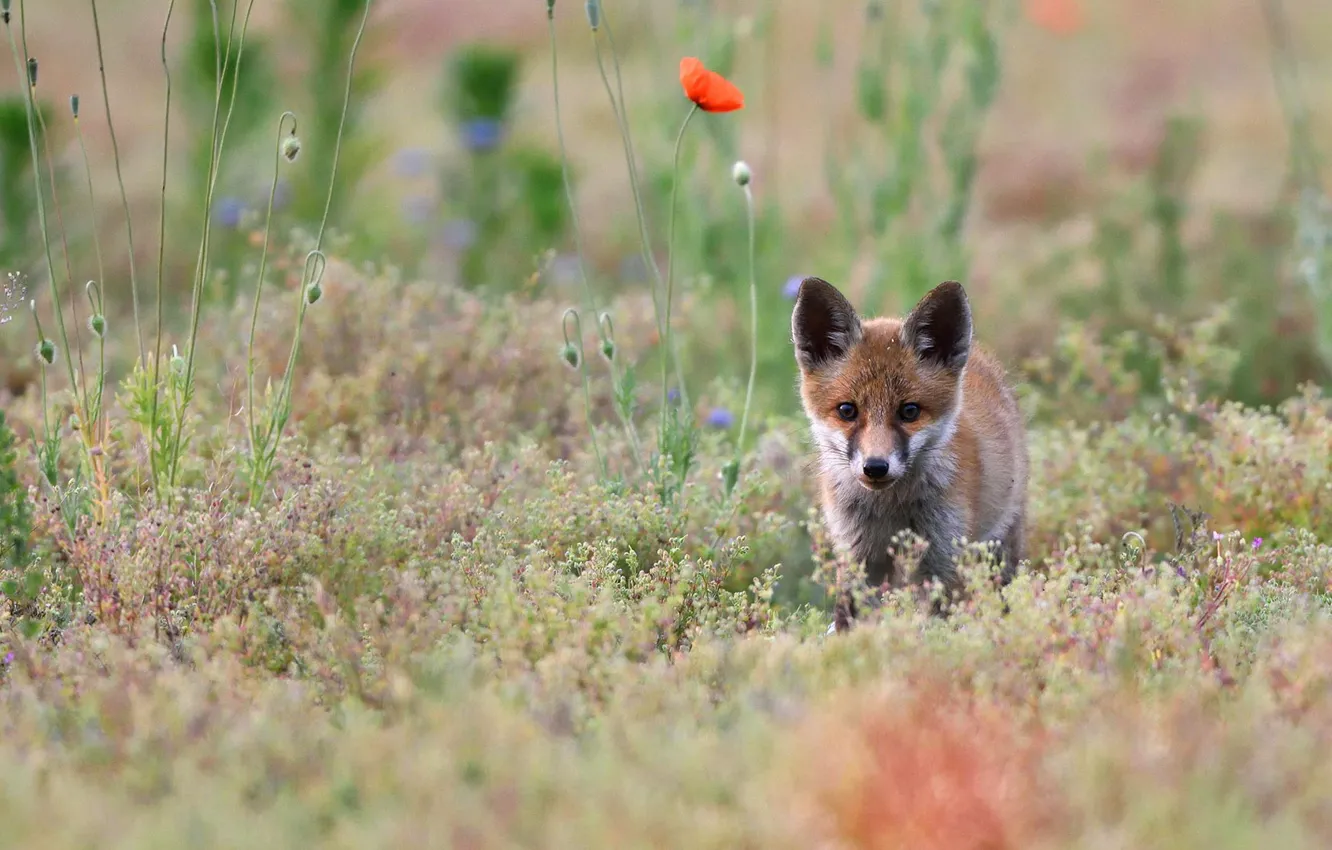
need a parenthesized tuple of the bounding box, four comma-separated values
(0, 0, 1332, 424)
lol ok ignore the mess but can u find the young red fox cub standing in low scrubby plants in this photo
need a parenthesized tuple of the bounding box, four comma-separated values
(791, 277, 1028, 633)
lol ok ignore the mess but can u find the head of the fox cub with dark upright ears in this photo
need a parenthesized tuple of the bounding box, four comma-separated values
(791, 277, 971, 490)
